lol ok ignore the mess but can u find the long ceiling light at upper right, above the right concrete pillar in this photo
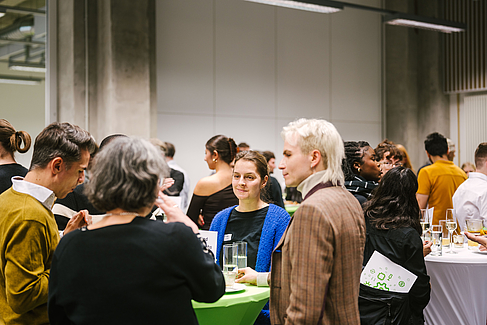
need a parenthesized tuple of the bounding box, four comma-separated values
(382, 13, 467, 33)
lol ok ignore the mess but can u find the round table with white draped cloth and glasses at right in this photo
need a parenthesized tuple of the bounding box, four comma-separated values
(424, 246, 487, 325)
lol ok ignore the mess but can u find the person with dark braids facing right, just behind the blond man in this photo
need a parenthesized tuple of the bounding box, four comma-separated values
(342, 141, 381, 205)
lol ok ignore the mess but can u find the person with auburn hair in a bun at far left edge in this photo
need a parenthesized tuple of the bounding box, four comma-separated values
(0, 119, 31, 194)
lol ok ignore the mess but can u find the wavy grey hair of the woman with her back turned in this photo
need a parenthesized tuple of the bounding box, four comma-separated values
(85, 137, 169, 212)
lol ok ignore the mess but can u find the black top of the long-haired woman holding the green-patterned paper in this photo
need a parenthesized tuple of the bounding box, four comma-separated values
(361, 218, 431, 318)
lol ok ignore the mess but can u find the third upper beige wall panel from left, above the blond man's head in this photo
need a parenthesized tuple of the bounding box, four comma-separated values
(277, 9, 331, 118)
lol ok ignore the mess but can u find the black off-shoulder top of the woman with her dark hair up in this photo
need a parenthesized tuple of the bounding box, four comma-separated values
(187, 184, 238, 230)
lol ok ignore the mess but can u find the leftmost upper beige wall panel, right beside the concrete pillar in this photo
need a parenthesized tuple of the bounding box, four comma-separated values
(156, 0, 214, 114)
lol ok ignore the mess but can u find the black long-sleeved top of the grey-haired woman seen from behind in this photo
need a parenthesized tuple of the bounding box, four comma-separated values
(48, 217, 225, 325)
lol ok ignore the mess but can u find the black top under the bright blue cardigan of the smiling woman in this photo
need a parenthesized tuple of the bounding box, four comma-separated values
(220, 206, 269, 270)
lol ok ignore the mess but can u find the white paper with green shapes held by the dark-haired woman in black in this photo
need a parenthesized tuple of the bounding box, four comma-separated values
(360, 251, 418, 293)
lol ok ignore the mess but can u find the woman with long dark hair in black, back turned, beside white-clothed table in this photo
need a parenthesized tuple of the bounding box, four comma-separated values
(359, 167, 431, 324)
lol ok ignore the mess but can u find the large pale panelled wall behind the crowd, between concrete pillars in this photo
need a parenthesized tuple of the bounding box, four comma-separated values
(156, 0, 382, 192)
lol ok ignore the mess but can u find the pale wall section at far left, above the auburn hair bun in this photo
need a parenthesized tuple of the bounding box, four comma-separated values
(0, 62, 45, 168)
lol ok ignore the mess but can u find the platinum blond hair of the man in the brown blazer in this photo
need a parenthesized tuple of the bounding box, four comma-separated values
(281, 118, 345, 185)
